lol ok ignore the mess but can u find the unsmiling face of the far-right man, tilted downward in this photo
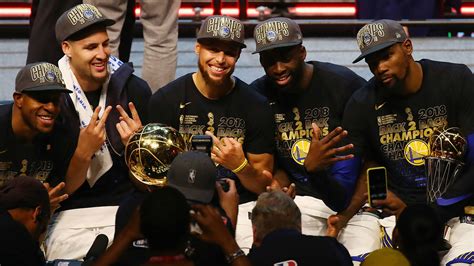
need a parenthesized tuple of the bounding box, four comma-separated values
(365, 40, 412, 95)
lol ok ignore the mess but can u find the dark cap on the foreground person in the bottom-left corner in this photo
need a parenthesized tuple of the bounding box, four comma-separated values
(0, 176, 50, 215)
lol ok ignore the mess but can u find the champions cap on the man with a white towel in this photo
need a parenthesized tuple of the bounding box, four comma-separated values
(55, 4, 115, 42)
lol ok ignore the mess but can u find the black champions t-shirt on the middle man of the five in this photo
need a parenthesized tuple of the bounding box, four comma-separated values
(148, 73, 274, 202)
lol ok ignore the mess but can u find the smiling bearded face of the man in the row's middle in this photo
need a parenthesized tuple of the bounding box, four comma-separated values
(195, 40, 241, 87)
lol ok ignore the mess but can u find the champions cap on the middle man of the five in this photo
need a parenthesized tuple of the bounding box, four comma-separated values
(197, 16, 247, 48)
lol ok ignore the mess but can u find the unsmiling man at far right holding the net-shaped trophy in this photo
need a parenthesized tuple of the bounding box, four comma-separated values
(336, 20, 474, 265)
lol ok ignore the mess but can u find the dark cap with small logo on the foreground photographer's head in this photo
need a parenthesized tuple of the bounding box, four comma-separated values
(167, 151, 217, 203)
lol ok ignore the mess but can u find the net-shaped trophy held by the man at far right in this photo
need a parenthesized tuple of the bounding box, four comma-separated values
(425, 127, 467, 203)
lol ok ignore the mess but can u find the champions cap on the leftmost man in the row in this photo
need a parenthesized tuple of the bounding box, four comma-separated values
(15, 62, 71, 93)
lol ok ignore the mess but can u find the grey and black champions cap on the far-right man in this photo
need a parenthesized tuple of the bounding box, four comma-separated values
(352, 19, 408, 63)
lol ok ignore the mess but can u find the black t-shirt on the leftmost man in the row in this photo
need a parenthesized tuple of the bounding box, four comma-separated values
(0, 104, 75, 185)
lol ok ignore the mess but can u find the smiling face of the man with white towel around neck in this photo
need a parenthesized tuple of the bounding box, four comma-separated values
(62, 26, 111, 91)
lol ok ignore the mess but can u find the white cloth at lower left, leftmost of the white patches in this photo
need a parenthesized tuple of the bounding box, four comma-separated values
(45, 206, 118, 260)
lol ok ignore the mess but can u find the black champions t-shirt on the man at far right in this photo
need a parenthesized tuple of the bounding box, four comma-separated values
(343, 60, 474, 205)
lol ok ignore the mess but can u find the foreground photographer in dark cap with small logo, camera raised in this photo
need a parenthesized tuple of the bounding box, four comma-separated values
(109, 151, 239, 266)
